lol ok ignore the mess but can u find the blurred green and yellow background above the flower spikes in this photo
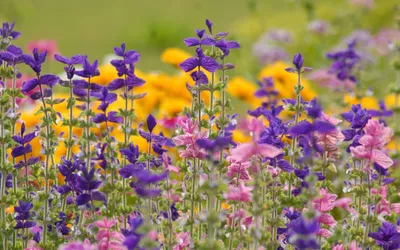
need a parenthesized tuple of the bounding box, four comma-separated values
(0, 0, 400, 111)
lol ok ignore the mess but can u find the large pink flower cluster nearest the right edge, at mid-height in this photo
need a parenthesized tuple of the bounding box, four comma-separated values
(350, 119, 393, 169)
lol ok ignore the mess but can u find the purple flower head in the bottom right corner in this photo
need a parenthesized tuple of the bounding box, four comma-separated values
(368, 222, 400, 250)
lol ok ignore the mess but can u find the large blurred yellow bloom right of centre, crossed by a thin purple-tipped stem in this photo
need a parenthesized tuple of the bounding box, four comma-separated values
(259, 62, 316, 101)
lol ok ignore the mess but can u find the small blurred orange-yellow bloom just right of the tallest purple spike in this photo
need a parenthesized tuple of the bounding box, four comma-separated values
(227, 76, 257, 103)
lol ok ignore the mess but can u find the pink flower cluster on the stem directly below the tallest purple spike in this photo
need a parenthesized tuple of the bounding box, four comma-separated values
(172, 119, 208, 159)
